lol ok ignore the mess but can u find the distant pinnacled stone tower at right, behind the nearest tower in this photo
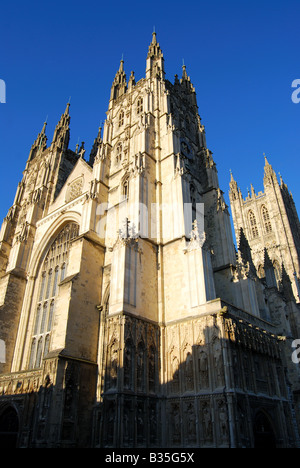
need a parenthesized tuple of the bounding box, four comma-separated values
(229, 156, 300, 302)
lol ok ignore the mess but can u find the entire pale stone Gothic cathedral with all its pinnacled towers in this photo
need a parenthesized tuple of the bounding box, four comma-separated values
(0, 33, 300, 449)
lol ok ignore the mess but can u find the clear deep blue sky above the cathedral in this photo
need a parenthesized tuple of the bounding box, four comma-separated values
(0, 0, 300, 238)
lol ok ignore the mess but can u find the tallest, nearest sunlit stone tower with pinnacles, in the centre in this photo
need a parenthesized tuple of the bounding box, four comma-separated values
(94, 33, 244, 447)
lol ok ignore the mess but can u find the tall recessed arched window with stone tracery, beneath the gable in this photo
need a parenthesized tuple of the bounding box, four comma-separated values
(29, 223, 79, 369)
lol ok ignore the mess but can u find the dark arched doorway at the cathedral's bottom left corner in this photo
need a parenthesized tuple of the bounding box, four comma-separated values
(0, 406, 19, 448)
